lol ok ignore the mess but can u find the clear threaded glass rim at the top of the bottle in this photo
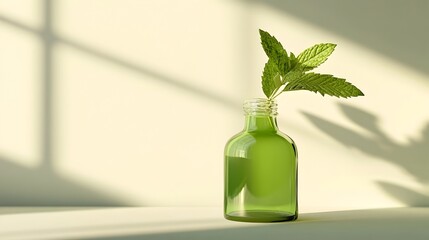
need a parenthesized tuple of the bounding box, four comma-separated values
(243, 98, 277, 116)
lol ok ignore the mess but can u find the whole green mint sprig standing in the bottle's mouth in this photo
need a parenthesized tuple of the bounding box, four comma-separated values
(259, 29, 364, 100)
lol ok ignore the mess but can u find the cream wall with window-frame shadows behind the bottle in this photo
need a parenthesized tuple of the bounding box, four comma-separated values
(0, 0, 429, 211)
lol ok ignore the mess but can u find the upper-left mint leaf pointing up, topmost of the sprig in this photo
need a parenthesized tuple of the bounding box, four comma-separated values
(259, 29, 290, 76)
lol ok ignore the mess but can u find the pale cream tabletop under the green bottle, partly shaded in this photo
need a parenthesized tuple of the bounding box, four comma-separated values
(0, 207, 429, 240)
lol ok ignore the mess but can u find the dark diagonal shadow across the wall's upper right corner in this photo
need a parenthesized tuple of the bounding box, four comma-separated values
(244, 0, 429, 75)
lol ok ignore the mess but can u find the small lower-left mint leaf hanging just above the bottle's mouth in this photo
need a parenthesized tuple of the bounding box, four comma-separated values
(262, 59, 282, 98)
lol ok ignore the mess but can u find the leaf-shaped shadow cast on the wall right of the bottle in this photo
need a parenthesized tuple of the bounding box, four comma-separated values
(303, 103, 429, 207)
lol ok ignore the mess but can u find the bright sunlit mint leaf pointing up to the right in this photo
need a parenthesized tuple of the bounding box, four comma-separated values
(297, 43, 337, 71)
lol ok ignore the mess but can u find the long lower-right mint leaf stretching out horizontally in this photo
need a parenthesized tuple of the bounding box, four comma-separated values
(283, 73, 364, 98)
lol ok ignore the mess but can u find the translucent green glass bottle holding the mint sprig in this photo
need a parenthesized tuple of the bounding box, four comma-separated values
(224, 99, 298, 222)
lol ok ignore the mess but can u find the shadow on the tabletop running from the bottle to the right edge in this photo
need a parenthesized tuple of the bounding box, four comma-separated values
(82, 208, 429, 240)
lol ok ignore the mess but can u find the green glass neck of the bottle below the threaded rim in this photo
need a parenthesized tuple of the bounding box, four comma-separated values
(244, 115, 278, 132)
